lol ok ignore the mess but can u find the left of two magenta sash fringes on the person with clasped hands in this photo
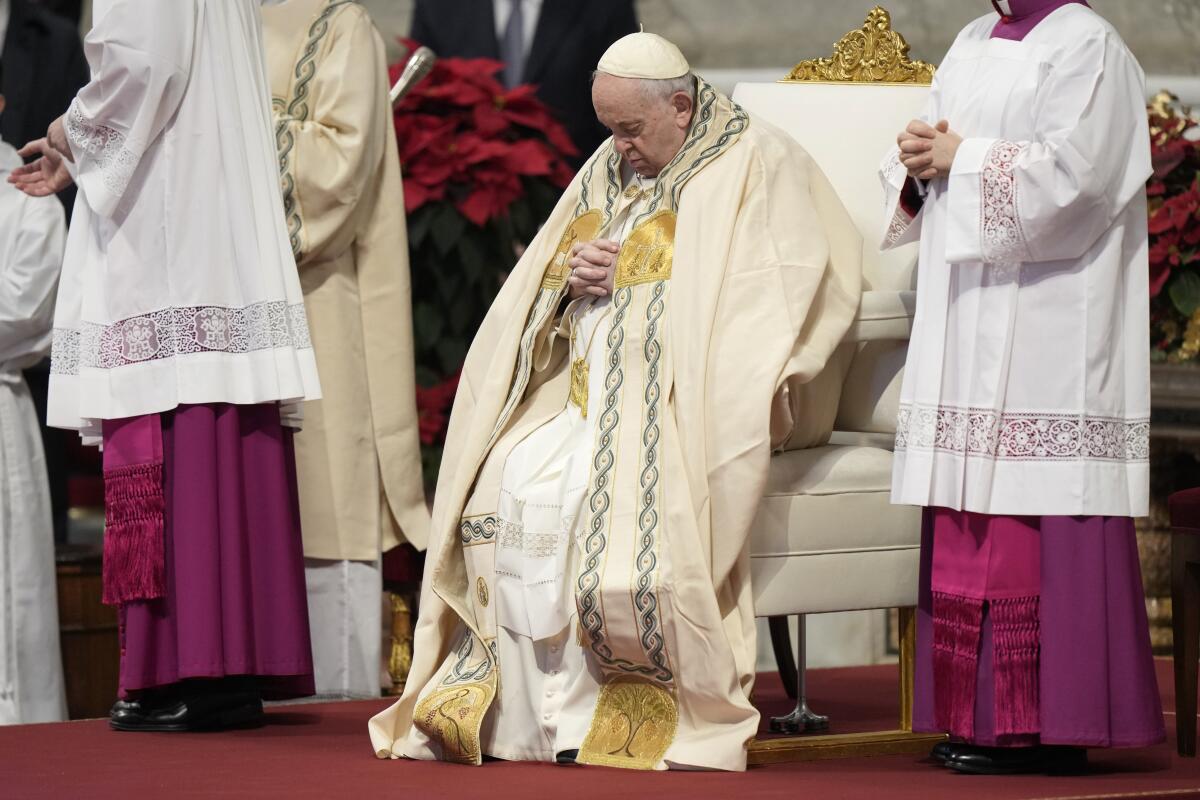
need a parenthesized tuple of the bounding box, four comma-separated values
(934, 591, 983, 739)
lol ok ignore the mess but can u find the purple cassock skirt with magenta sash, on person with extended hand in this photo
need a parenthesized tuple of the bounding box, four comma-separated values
(104, 404, 313, 699)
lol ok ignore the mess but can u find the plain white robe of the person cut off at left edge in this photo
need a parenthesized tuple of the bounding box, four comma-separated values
(0, 142, 66, 724)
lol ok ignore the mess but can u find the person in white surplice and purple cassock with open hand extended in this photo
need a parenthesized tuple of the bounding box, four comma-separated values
(11, 0, 319, 730)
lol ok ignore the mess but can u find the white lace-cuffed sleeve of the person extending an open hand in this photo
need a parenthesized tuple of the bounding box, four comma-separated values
(66, 0, 198, 217)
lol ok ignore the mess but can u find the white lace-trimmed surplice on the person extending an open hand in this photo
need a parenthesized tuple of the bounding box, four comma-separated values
(49, 0, 319, 434)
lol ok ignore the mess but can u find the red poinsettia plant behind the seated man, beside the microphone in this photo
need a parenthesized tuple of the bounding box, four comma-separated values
(391, 40, 577, 480)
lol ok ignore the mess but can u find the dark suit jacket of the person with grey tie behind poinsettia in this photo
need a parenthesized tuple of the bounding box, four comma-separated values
(409, 0, 637, 167)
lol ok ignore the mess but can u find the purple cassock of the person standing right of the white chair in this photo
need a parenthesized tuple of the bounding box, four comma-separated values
(913, 0, 1165, 747)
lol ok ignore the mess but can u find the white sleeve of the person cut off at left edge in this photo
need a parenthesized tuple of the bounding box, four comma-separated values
(0, 195, 66, 362)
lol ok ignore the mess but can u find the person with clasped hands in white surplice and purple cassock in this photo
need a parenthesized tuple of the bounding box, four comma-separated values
(882, 0, 1164, 772)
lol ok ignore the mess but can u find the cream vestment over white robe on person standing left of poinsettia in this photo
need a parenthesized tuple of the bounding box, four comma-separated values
(263, 0, 428, 697)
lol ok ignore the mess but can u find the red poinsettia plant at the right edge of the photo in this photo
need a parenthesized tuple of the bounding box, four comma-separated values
(1146, 92, 1200, 363)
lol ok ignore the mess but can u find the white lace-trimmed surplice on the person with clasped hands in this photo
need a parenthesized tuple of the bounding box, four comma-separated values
(881, 4, 1151, 516)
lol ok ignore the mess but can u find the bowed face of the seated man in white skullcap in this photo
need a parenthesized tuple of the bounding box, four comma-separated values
(592, 73, 691, 178)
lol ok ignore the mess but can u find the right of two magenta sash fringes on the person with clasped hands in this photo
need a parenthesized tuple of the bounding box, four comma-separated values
(988, 595, 1042, 736)
